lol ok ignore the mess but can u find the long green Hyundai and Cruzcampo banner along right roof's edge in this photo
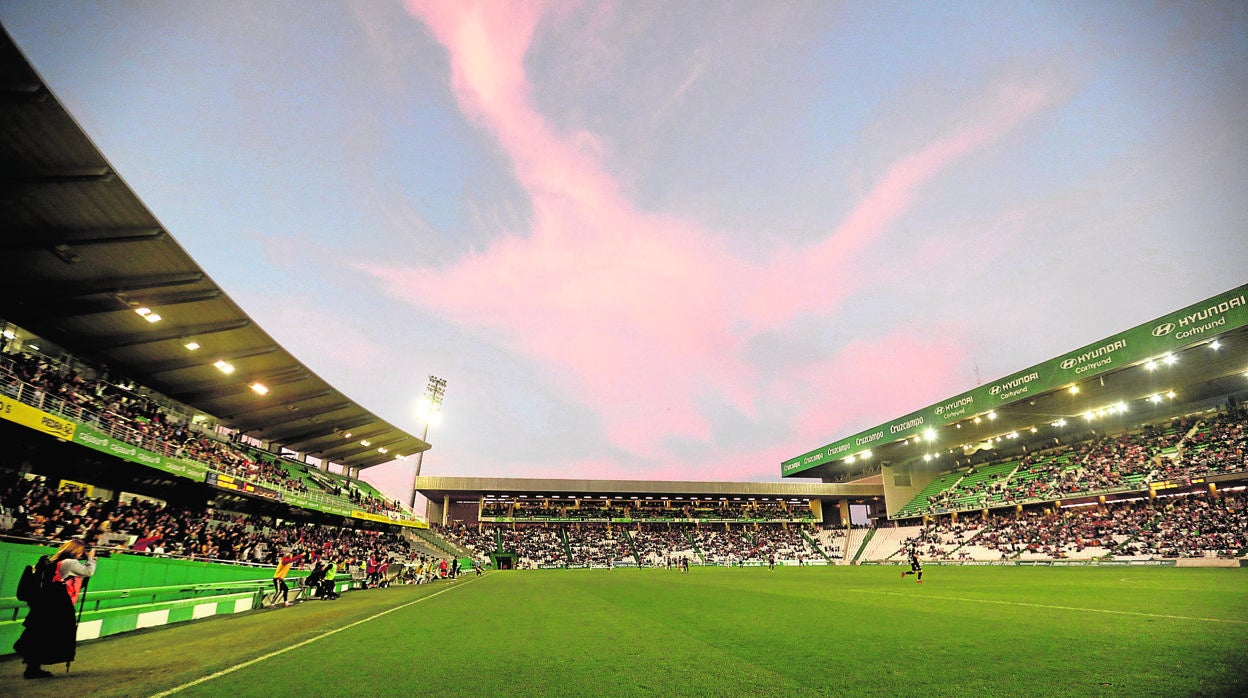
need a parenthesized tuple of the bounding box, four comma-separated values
(780, 285, 1248, 476)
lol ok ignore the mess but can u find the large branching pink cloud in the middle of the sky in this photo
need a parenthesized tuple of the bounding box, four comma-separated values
(361, 0, 1045, 479)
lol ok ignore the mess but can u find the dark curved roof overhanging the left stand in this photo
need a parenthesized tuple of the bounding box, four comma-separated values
(0, 25, 429, 467)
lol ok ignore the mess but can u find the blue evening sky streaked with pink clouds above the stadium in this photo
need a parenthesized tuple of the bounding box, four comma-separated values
(0, 0, 1248, 501)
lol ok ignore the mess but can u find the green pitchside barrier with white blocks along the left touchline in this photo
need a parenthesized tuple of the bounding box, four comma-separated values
(0, 542, 358, 656)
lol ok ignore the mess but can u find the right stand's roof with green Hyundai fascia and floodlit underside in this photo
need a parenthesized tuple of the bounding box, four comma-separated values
(781, 285, 1248, 479)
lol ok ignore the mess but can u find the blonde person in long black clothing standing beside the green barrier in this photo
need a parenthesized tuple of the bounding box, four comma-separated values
(12, 538, 95, 678)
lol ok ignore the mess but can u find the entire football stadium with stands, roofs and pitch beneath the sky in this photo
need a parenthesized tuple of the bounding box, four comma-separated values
(0, 14, 1248, 696)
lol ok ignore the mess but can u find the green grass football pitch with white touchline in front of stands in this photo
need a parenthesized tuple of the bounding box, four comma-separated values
(0, 566, 1248, 697)
